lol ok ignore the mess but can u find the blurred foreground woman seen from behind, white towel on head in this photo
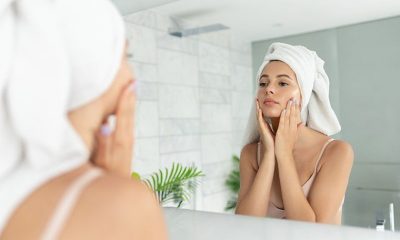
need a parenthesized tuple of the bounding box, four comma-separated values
(0, 0, 166, 239)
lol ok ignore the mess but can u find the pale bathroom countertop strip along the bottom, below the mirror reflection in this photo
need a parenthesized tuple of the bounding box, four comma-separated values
(164, 208, 400, 240)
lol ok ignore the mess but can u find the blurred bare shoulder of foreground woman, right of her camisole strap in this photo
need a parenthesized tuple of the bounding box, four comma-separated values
(62, 170, 165, 239)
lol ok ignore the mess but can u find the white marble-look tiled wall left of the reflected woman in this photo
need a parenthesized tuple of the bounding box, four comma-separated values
(125, 11, 253, 212)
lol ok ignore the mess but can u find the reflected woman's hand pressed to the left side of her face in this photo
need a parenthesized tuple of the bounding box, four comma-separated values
(256, 99, 275, 155)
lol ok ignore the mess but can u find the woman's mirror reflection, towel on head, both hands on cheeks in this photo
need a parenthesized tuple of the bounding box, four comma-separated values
(236, 43, 353, 224)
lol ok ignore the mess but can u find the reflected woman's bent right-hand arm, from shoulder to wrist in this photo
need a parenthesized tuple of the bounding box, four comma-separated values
(278, 140, 353, 223)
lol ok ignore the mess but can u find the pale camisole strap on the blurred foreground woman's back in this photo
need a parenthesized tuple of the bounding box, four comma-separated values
(41, 168, 102, 240)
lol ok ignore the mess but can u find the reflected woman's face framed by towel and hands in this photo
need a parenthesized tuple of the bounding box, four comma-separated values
(257, 61, 301, 118)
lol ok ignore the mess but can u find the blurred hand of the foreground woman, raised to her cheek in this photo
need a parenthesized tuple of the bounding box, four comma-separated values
(91, 82, 136, 177)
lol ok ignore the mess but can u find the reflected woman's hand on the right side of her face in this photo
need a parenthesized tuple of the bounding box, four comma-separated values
(275, 100, 303, 161)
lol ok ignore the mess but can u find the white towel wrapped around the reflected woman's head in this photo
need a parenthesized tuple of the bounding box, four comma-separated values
(244, 42, 341, 144)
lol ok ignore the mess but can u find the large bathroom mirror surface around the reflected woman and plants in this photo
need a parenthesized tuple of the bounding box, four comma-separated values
(114, 0, 400, 230)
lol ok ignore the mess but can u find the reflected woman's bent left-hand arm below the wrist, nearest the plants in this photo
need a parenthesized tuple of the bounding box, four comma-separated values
(236, 144, 275, 217)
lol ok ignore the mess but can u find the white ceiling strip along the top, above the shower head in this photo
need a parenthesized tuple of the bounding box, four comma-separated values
(149, 0, 400, 42)
